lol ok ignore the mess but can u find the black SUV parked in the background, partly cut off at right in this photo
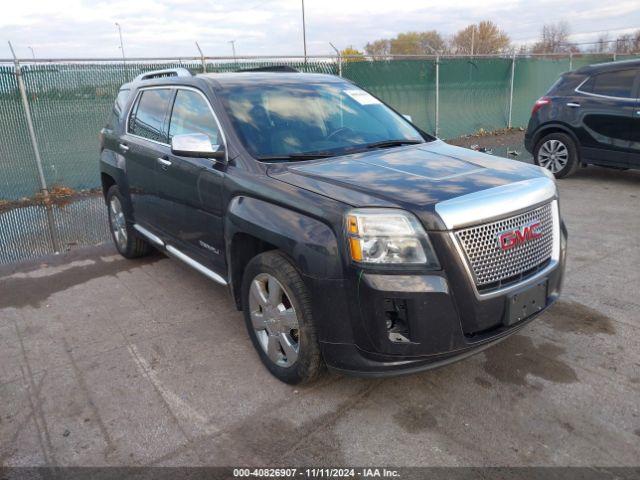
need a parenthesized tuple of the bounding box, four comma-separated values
(525, 60, 640, 178)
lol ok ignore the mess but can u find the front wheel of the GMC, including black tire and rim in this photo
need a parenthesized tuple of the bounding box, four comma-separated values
(242, 250, 324, 385)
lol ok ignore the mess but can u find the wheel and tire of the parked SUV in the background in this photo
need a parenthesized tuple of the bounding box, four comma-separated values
(533, 133, 580, 178)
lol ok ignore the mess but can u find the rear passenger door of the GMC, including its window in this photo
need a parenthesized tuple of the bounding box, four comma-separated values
(119, 87, 173, 228)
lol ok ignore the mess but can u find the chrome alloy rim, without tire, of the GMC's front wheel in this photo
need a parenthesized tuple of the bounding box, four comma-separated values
(249, 273, 300, 367)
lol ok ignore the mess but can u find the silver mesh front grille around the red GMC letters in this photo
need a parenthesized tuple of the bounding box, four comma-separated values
(455, 203, 553, 291)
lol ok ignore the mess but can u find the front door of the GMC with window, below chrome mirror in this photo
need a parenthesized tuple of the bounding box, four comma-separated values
(156, 87, 226, 272)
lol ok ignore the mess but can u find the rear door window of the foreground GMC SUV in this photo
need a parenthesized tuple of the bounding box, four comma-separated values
(129, 89, 172, 143)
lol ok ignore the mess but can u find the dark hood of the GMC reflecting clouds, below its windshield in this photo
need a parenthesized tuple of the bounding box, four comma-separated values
(268, 140, 545, 229)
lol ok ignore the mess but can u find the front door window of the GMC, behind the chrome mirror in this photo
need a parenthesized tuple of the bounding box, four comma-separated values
(169, 90, 222, 145)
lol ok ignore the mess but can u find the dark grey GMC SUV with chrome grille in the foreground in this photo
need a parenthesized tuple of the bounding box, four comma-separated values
(100, 69, 566, 383)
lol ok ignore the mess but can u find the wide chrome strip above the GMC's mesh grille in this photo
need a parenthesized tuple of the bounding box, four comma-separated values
(435, 176, 557, 230)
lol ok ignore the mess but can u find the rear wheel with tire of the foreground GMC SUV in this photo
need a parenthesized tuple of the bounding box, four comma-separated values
(107, 185, 151, 258)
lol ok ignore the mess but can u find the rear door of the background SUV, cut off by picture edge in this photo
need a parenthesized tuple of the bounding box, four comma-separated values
(567, 69, 638, 167)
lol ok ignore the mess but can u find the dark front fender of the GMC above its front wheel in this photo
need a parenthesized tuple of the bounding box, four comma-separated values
(225, 196, 342, 279)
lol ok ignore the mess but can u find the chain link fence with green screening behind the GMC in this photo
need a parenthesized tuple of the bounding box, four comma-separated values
(0, 55, 636, 264)
